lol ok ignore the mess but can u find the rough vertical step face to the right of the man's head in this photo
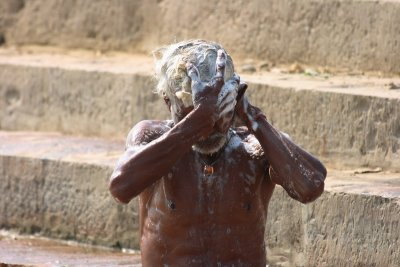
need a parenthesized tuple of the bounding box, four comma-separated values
(244, 76, 400, 170)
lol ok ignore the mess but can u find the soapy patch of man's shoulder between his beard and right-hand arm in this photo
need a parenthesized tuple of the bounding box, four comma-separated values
(228, 126, 264, 158)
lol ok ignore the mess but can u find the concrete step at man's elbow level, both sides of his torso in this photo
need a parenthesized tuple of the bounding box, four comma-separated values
(0, 131, 400, 267)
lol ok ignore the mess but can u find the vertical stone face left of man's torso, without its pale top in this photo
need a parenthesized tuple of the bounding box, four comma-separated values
(0, 156, 139, 249)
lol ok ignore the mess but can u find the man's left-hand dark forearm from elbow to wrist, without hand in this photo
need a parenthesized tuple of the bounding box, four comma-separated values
(110, 104, 213, 203)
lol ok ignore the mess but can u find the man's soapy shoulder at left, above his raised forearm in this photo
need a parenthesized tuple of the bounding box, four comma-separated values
(126, 120, 173, 147)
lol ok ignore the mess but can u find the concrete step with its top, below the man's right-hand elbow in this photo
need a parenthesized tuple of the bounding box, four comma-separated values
(266, 171, 400, 267)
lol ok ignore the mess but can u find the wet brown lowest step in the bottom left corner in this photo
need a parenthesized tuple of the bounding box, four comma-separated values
(0, 231, 141, 267)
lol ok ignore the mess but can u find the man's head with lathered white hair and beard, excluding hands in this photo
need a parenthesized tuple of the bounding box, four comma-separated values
(154, 40, 238, 154)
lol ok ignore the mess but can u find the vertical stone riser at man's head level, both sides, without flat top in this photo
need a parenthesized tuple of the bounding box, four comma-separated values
(0, 61, 400, 170)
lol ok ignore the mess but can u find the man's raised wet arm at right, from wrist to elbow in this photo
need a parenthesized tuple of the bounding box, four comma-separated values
(237, 88, 327, 203)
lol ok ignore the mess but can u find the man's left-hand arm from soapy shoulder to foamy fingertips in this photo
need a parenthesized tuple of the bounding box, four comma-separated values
(109, 52, 234, 203)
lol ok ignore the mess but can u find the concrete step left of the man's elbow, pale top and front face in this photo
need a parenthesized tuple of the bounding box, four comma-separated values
(0, 133, 143, 248)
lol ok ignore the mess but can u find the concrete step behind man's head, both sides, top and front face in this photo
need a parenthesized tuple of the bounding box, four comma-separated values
(0, 48, 400, 170)
